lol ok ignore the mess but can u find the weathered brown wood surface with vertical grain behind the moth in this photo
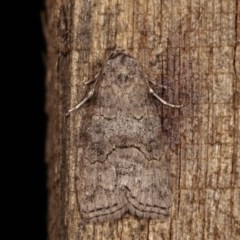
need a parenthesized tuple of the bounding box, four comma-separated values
(45, 0, 240, 240)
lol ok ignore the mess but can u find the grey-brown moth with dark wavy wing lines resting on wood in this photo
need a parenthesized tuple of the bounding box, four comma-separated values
(67, 51, 181, 222)
